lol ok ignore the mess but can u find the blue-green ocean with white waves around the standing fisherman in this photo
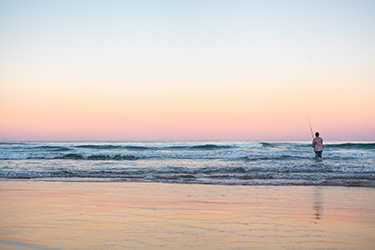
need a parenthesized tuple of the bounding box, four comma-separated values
(0, 141, 375, 187)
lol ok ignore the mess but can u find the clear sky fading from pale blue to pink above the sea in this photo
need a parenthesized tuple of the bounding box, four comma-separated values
(0, 0, 375, 141)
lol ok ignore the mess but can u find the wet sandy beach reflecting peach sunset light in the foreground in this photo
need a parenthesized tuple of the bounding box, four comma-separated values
(0, 181, 375, 249)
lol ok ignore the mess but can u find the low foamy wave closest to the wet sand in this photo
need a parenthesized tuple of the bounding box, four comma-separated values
(0, 164, 375, 187)
